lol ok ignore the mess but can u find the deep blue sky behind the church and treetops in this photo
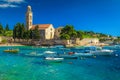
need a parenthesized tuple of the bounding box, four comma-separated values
(0, 0, 120, 36)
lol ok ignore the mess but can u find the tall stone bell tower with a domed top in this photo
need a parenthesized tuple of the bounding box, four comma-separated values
(26, 6, 33, 30)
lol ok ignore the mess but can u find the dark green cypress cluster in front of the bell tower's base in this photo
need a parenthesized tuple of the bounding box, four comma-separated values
(13, 23, 40, 40)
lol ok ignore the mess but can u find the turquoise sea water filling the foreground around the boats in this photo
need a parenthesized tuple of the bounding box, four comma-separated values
(0, 46, 120, 80)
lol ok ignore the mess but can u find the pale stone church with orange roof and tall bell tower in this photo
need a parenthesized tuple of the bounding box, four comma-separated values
(26, 6, 55, 40)
